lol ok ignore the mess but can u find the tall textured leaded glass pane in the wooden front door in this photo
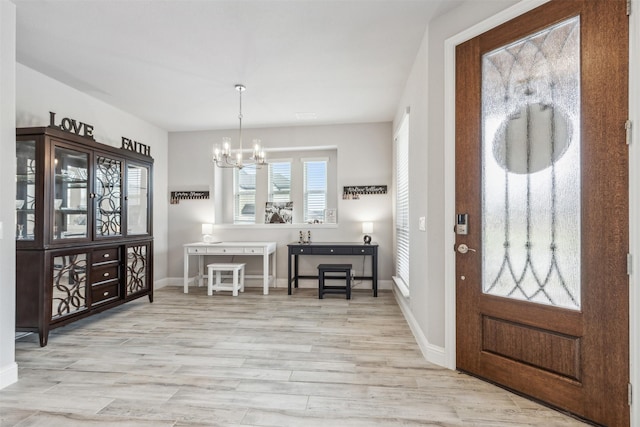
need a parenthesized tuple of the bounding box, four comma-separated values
(482, 17, 580, 310)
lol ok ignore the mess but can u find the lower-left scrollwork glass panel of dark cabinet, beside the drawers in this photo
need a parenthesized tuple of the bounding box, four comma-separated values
(51, 253, 87, 320)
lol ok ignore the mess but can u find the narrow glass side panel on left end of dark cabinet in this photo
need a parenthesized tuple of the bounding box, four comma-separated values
(16, 140, 36, 240)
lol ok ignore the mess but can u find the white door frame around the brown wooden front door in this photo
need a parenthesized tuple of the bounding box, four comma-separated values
(443, 0, 640, 426)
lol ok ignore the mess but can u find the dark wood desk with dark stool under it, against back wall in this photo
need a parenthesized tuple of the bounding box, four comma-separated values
(287, 242, 378, 297)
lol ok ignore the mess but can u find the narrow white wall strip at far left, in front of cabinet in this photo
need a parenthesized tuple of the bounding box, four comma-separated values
(0, 0, 18, 389)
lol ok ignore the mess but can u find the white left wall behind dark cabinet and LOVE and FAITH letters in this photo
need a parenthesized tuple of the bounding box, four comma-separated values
(14, 64, 169, 281)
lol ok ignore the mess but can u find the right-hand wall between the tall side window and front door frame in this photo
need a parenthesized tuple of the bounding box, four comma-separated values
(393, 0, 517, 365)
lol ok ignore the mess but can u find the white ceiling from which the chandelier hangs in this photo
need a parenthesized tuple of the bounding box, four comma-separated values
(11, 0, 461, 131)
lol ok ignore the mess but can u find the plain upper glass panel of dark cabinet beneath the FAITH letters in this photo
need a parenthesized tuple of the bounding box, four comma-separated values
(126, 164, 150, 236)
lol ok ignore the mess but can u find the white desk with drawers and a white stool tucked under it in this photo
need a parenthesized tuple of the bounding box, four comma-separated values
(184, 242, 276, 295)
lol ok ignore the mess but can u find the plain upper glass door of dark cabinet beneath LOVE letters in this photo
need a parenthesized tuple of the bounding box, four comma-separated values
(51, 146, 89, 240)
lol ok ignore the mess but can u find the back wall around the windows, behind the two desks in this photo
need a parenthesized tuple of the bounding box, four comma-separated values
(169, 123, 393, 287)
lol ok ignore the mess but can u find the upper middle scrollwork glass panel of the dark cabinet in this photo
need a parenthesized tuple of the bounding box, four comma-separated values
(96, 156, 122, 236)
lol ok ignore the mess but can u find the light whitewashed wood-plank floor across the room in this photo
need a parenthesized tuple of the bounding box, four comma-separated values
(0, 287, 585, 427)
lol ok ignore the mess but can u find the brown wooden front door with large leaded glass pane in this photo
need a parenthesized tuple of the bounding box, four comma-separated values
(455, 0, 630, 426)
